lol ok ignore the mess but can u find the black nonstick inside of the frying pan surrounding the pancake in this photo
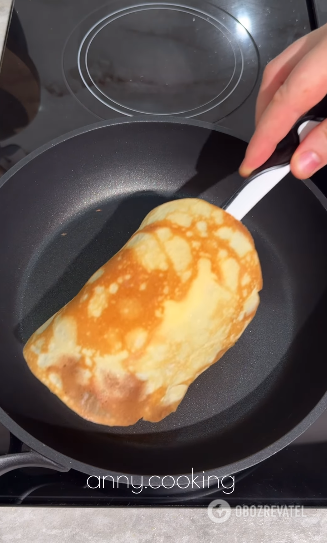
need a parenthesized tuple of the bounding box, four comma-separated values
(0, 120, 327, 480)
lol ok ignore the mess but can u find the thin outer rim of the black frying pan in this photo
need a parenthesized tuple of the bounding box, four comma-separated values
(0, 115, 327, 484)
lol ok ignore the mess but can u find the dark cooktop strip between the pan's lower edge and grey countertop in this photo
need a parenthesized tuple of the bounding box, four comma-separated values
(0, 413, 327, 507)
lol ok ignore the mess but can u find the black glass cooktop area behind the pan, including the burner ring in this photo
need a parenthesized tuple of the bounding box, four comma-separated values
(0, 0, 318, 172)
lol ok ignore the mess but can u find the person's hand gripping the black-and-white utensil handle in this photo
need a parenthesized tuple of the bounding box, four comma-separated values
(239, 25, 327, 179)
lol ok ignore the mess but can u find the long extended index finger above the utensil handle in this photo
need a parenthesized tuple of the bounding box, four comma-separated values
(240, 42, 327, 176)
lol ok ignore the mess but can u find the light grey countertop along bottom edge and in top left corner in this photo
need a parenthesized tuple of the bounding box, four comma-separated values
(0, 0, 327, 543)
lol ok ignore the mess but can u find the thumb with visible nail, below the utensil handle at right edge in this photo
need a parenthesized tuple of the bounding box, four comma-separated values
(291, 120, 327, 179)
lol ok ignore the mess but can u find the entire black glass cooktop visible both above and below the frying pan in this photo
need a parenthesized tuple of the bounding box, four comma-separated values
(0, 0, 327, 506)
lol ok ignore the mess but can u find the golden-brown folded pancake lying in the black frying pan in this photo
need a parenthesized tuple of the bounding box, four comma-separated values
(24, 199, 262, 426)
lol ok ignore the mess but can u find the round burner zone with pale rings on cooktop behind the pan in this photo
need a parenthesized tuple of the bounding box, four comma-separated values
(63, 0, 258, 121)
